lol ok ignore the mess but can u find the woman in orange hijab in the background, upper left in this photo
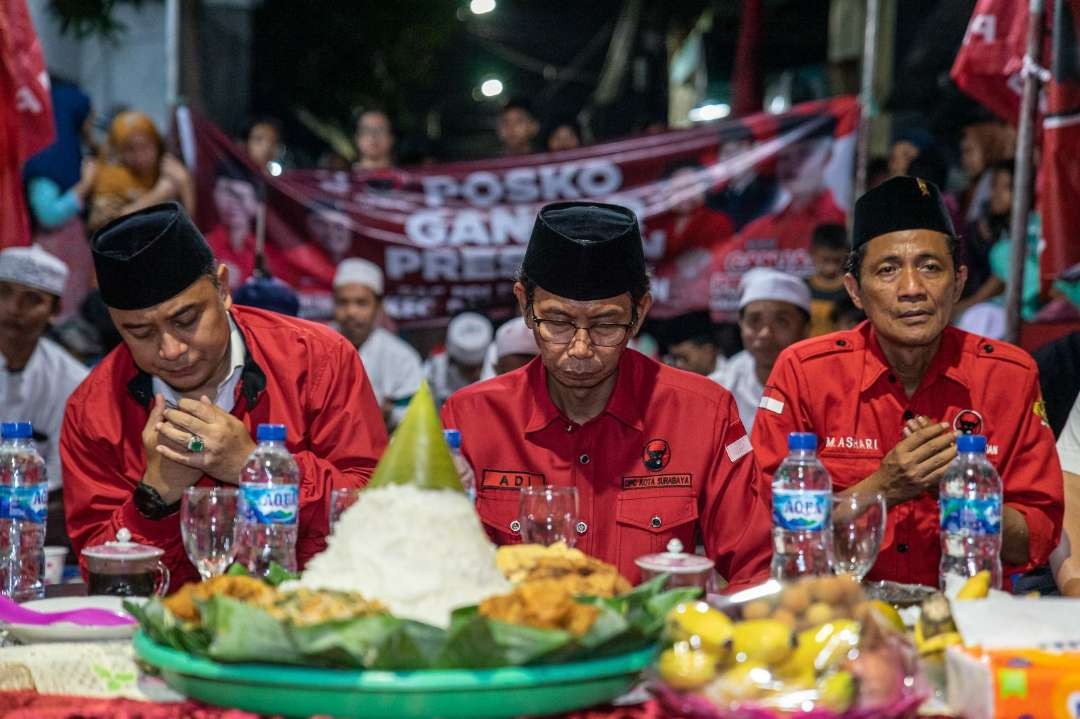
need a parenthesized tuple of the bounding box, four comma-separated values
(87, 111, 194, 231)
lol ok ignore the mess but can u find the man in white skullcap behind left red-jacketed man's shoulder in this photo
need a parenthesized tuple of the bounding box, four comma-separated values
(334, 257, 423, 430)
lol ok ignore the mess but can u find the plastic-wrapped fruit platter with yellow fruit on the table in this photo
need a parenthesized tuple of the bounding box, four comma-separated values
(656, 576, 930, 719)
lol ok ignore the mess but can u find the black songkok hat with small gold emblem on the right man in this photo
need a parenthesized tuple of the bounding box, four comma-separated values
(851, 177, 956, 249)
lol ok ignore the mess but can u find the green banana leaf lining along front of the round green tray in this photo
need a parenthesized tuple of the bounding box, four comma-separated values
(125, 576, 700, 670)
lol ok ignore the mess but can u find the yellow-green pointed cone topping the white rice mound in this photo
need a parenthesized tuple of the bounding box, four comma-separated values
(367, 382, 464, 492)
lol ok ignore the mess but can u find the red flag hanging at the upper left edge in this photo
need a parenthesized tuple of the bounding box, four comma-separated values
(0, 0, 56, 247)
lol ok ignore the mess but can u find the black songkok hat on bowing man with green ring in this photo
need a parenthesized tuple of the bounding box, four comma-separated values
(90, 202, 214, 310)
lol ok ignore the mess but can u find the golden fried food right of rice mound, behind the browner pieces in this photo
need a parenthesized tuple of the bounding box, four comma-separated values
(496, 542, 633, 597)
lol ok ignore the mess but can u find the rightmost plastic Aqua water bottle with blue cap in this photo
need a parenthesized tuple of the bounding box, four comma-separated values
(937, 434, 1001, 589)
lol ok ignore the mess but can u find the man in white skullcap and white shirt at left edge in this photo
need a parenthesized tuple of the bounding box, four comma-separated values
(0, 245, 89, 543)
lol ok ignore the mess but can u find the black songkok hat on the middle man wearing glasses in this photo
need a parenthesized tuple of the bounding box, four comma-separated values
(522, 202, 648, 300)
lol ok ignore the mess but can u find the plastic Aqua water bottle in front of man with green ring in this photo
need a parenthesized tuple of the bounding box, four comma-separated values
(235, 424, 300, 576)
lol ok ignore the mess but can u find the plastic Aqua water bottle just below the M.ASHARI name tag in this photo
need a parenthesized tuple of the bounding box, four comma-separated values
(772, 432, 833, 580)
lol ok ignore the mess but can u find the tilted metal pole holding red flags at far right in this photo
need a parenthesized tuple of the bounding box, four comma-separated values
(1005, 0, 1044, 343)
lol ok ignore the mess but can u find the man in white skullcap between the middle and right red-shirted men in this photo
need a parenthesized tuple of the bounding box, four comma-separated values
(710, 268, 810, 434)
